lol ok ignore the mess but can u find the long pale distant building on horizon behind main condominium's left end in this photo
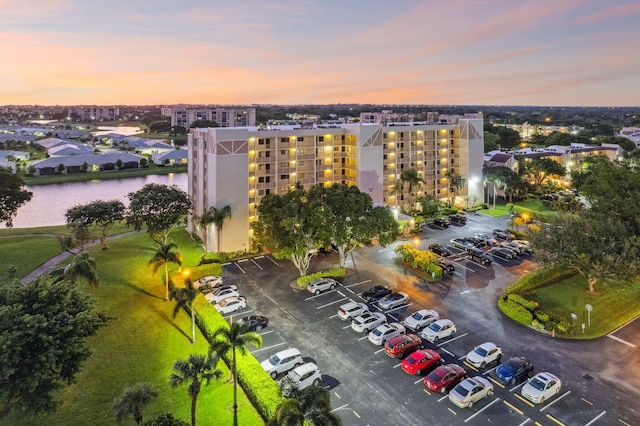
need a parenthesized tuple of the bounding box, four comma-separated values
(161, 107, 256, 128)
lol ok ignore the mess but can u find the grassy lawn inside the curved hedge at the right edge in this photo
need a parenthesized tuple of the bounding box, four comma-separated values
(523, 274, 640, 339)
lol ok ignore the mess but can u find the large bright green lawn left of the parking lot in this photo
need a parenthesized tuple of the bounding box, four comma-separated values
(0, 231, 263, 426)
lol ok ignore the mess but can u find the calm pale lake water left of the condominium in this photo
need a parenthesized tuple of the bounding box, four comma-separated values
(8, 173, 187, 228)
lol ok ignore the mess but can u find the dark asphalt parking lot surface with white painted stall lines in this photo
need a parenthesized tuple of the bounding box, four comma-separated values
(212, 215, 640, 425)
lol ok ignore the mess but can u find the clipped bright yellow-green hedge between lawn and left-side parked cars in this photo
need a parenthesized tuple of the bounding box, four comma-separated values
(193, 295, 284, 422)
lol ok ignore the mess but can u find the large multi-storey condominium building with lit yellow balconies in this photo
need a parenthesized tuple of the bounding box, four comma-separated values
(188, 118, 484, 252)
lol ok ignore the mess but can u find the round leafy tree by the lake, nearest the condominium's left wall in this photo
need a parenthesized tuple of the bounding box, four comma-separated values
(126, 183, 193, 244)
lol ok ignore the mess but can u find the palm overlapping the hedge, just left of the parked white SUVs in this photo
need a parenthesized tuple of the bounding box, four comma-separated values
(209, 322, 262, 426)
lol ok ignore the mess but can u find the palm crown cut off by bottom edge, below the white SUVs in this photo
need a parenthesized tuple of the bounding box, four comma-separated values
(269, 386, 342, 426)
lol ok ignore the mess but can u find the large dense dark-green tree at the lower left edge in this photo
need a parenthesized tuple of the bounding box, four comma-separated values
(0, 276, 109, 416)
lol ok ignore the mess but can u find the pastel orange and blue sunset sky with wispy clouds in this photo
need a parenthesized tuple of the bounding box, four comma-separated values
(0, 0, 640, 106)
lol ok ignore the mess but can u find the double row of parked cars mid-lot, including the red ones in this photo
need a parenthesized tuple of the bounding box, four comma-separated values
(338, 285, 561, 408)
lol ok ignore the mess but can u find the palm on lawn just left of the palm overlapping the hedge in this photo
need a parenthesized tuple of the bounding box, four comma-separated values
(169, 353, 222, 426)
